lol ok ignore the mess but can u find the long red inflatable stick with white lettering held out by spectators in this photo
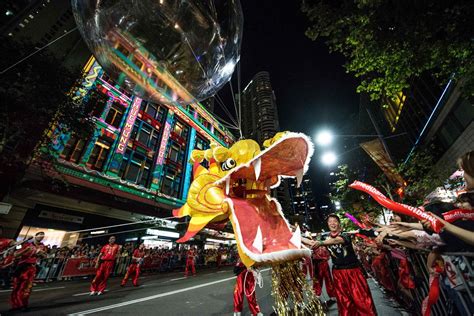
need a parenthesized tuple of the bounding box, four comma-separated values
(349, 181, 444, 233)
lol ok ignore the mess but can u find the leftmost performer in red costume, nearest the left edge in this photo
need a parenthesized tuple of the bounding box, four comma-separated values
(11, 232, 46, 311)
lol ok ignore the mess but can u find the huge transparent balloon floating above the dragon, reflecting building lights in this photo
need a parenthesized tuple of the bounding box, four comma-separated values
(72, 0, 243, 105)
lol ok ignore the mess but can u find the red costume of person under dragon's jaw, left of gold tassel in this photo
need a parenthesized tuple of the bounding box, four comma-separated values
(234, 261, 260, 315)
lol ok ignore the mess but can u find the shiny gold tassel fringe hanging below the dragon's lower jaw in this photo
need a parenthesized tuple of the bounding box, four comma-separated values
(272, 260, 326, 316)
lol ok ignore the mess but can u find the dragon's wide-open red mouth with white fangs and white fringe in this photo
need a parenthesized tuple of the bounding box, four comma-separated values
(216, 133, 313, 264)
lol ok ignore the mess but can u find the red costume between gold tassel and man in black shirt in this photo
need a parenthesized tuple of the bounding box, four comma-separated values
(313, 247, 334, 297)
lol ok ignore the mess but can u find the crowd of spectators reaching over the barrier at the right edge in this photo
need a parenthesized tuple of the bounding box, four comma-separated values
(330, 152, 474, 315)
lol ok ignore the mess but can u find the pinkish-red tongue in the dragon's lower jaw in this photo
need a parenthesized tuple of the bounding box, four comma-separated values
(232, 197, 298, 254)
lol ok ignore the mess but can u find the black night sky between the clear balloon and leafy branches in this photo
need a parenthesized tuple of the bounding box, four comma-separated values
(218, 0, 359, 203)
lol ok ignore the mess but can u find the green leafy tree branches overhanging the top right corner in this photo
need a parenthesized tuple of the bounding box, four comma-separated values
(302, 0, 474, 100)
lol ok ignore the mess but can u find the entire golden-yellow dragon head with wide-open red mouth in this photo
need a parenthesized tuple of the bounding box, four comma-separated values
(173, 132, 313, 267)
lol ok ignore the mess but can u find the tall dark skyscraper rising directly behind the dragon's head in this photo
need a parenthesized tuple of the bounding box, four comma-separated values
(241, 71, 292, 214)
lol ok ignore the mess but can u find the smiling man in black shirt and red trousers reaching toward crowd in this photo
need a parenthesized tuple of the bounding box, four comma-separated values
(314, 214, 377, 316)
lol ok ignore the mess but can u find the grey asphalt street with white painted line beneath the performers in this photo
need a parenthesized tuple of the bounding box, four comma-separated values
(0, 267, 401, 316)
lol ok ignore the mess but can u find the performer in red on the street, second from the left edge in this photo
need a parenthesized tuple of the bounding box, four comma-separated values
(90, 236, 120, 295)
